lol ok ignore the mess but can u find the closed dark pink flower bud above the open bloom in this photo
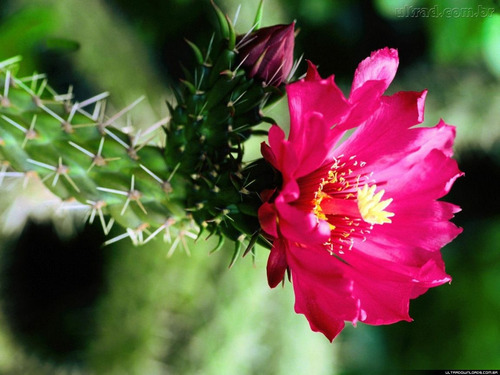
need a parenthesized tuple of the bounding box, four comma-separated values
(236, 23, 295, 86)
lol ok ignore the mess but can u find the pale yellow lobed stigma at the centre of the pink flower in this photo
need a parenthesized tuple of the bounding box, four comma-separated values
(358, 185, 394, 224)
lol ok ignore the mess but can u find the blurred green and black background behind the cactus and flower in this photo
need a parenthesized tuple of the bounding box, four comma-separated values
(0, 0, 500, 375)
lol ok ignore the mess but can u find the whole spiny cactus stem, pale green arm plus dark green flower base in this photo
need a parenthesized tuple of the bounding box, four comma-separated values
(0, 9, 282, 259)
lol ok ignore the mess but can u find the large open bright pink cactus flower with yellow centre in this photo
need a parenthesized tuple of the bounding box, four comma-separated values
(259, 48, 462, 341)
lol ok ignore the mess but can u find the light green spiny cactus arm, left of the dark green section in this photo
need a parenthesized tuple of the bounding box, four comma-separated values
(0, 58, 191, 248)
